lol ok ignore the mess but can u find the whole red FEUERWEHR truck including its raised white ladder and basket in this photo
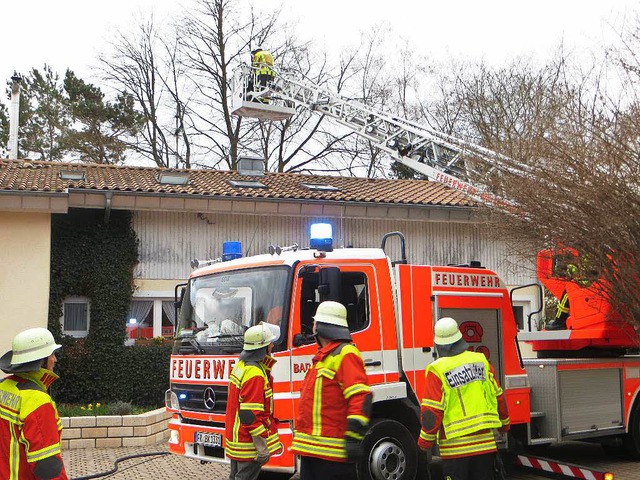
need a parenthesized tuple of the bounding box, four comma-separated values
(166, 65, 640, 480)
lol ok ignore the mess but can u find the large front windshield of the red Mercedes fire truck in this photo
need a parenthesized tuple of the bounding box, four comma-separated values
(174, 266, 289, 354)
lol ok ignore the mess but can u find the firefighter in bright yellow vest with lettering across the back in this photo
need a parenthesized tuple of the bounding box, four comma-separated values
(418, 317, 509, 480)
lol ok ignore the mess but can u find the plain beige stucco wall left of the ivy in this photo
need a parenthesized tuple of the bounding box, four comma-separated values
(0, 212, 51, 355)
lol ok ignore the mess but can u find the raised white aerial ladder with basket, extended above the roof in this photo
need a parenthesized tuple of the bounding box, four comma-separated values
(231, 65, 511, 205)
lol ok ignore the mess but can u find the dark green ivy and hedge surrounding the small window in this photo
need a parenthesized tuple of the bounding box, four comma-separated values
(49, 209, 171, 406)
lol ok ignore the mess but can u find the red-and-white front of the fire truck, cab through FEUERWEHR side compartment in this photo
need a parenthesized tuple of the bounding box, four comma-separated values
(166, 227, 530, 480)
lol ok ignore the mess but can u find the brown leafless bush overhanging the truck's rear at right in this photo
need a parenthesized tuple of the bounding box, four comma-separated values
(422, 44, 640, 326)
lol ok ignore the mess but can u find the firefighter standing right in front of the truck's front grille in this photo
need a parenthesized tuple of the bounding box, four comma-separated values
(225, 322, 283, 480)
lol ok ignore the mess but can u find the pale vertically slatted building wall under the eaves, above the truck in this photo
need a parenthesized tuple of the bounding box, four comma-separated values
(134, 211, 535, 285)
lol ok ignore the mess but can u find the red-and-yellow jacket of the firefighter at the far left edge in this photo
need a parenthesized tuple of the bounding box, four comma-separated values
(0, 368, 68, 480)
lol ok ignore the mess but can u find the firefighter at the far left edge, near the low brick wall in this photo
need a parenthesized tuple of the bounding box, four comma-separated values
(0, 328, 68, 480)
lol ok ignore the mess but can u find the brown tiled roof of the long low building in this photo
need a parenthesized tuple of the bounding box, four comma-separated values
(0, 159, 475, 207)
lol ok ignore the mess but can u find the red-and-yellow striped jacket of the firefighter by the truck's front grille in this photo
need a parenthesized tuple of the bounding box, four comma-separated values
(225, 356, 283, 462)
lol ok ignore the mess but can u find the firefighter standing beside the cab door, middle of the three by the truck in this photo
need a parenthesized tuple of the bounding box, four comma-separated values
(291, 301, 372, 480)
